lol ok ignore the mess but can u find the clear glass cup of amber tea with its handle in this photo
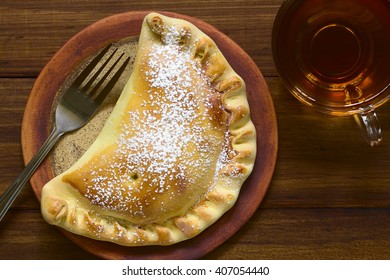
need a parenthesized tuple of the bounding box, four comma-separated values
(272, 0, 390, 146)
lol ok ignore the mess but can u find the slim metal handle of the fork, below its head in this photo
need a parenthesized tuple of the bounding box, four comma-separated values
(0, 127, 64, 221)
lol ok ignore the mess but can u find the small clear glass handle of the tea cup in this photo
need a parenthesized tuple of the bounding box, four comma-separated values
(354, 107, 382, 147)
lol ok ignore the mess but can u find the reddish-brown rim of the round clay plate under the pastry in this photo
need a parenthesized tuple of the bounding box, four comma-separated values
(22, 11, 277, 259)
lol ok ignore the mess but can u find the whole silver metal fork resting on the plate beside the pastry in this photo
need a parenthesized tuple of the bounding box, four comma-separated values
(0, 44, 130, 221)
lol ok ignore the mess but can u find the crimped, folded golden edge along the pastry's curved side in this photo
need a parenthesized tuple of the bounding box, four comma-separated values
(42, 13, 256, 246)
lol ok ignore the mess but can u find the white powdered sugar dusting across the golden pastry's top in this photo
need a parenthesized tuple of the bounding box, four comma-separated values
(80, 27, 232, 217)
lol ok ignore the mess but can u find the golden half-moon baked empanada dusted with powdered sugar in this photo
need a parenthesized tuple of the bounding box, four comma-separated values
(41, 13, 256, 246)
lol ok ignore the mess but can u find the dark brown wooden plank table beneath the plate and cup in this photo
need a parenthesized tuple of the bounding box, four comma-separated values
(0, 0, 390, 259)
